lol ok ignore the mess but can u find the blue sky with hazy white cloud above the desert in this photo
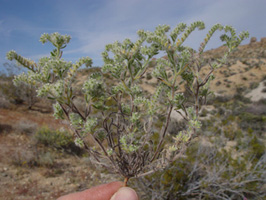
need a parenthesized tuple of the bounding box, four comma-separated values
(0, 0, 266, 72)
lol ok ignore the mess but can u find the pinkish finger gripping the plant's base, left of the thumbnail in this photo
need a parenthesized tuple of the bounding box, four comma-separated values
(57, 181, 123, 200)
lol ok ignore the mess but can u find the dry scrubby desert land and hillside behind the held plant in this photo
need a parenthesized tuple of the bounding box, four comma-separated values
(0, 38, 266, 200)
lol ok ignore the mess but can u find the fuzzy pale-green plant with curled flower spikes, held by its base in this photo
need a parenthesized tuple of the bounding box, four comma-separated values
(7, 21, 248, 184)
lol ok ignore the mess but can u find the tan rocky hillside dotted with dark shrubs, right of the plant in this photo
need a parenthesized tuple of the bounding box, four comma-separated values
(205, 38, 266, 95)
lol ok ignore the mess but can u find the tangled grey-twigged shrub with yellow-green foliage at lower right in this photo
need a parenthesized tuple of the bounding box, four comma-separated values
(134, 139, 266, 200)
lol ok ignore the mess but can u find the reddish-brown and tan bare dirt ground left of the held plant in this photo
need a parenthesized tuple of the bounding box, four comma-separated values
(0, 108, 117, 200)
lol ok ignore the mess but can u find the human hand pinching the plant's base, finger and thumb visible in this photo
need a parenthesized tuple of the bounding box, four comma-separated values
(57, 182, 139, 200)
